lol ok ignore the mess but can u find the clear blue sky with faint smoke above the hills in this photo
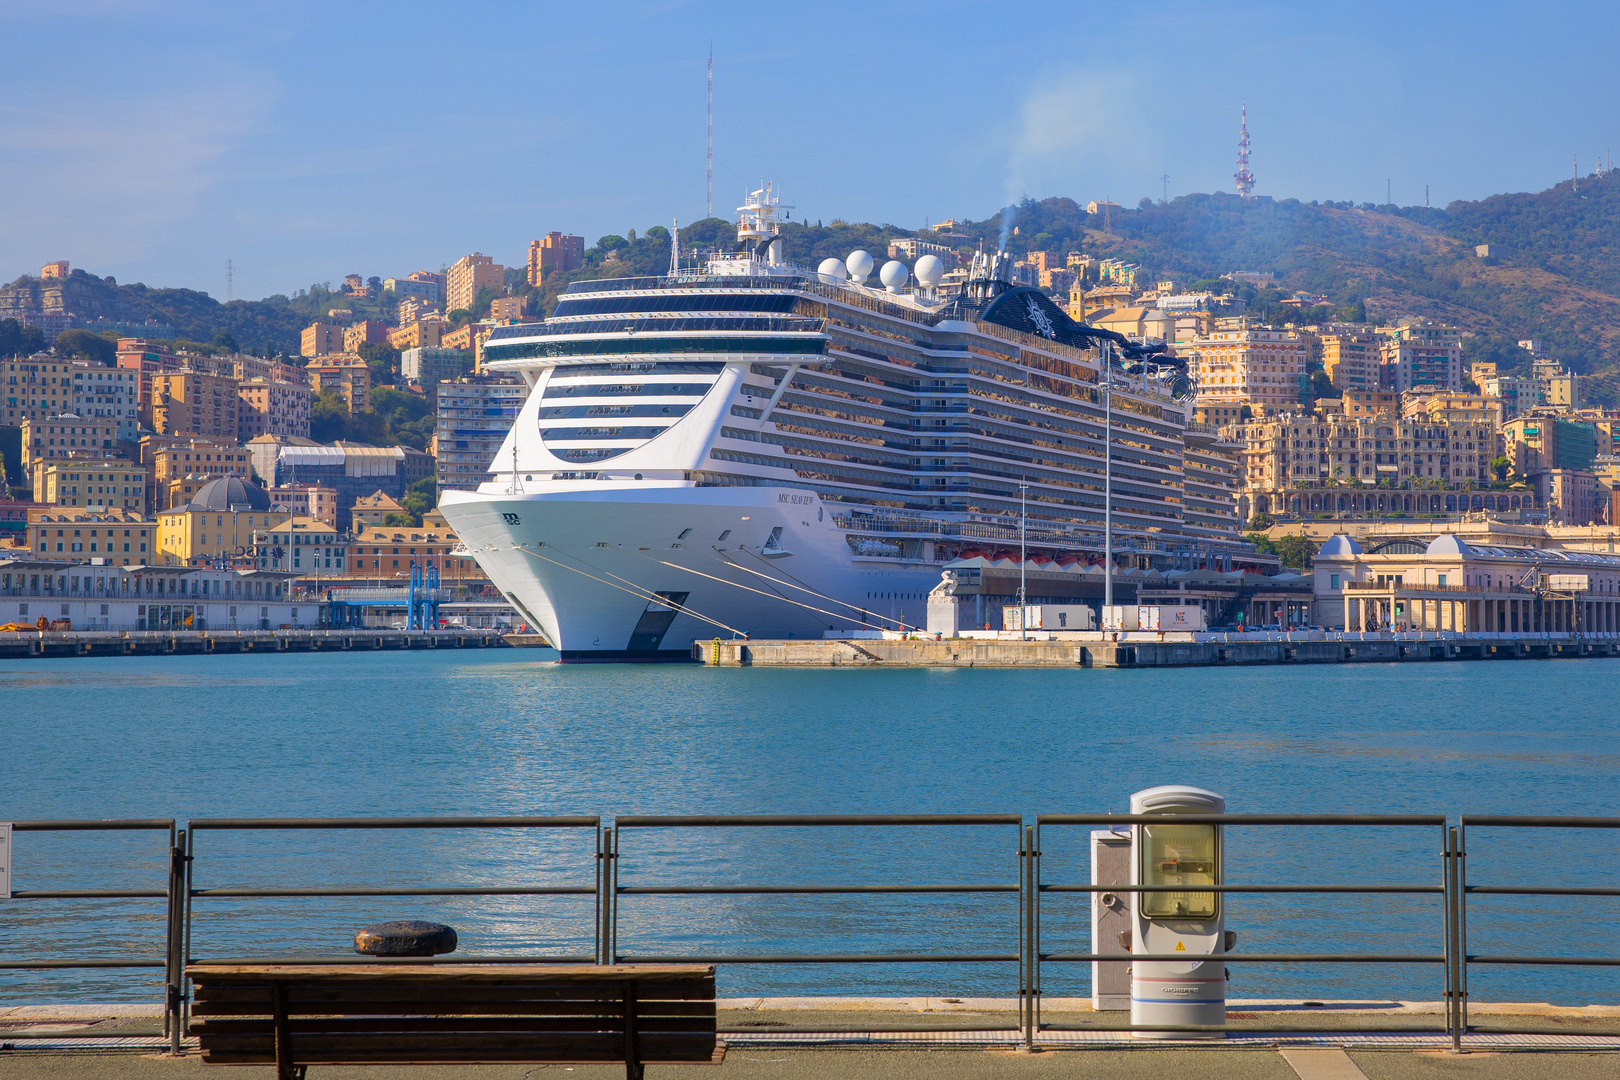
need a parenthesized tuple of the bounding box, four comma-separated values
(0, 0, 1620, 298)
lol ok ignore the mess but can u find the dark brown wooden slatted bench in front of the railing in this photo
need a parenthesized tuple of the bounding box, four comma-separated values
(186, 962, 724, 1080)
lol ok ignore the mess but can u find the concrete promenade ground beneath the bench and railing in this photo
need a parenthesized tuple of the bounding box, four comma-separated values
(0, 997, 1620, 1080)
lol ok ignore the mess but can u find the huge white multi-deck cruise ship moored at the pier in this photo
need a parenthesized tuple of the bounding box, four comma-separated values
(441, 186, 1246, 661)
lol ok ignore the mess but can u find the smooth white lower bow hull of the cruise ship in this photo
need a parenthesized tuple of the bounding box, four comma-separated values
(441, 483, 940, 661)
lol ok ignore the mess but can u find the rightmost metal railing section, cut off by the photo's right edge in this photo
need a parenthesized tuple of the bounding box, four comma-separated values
(1448, 814, 1620, 1046)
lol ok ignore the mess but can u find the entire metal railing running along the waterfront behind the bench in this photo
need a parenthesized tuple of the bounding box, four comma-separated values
(0, 814, 1620, 1052)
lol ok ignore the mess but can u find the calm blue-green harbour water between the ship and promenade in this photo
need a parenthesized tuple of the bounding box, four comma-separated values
(0, 649, 1620, 1004)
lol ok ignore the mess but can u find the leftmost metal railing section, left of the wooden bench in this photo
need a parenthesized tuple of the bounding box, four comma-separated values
(0, 818, 185, 1048)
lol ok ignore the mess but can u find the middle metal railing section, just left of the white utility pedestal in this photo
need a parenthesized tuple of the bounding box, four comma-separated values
(604, 814, 1029, 1035)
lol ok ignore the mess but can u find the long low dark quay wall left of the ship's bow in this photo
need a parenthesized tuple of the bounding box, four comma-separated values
(0, 627, 507, 659)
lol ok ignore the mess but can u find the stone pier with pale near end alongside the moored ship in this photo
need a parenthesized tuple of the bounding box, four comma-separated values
(692, 631, 1620, 667)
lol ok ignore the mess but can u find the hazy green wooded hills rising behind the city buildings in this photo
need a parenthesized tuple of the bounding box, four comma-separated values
(0, 173, 1620, 405)
